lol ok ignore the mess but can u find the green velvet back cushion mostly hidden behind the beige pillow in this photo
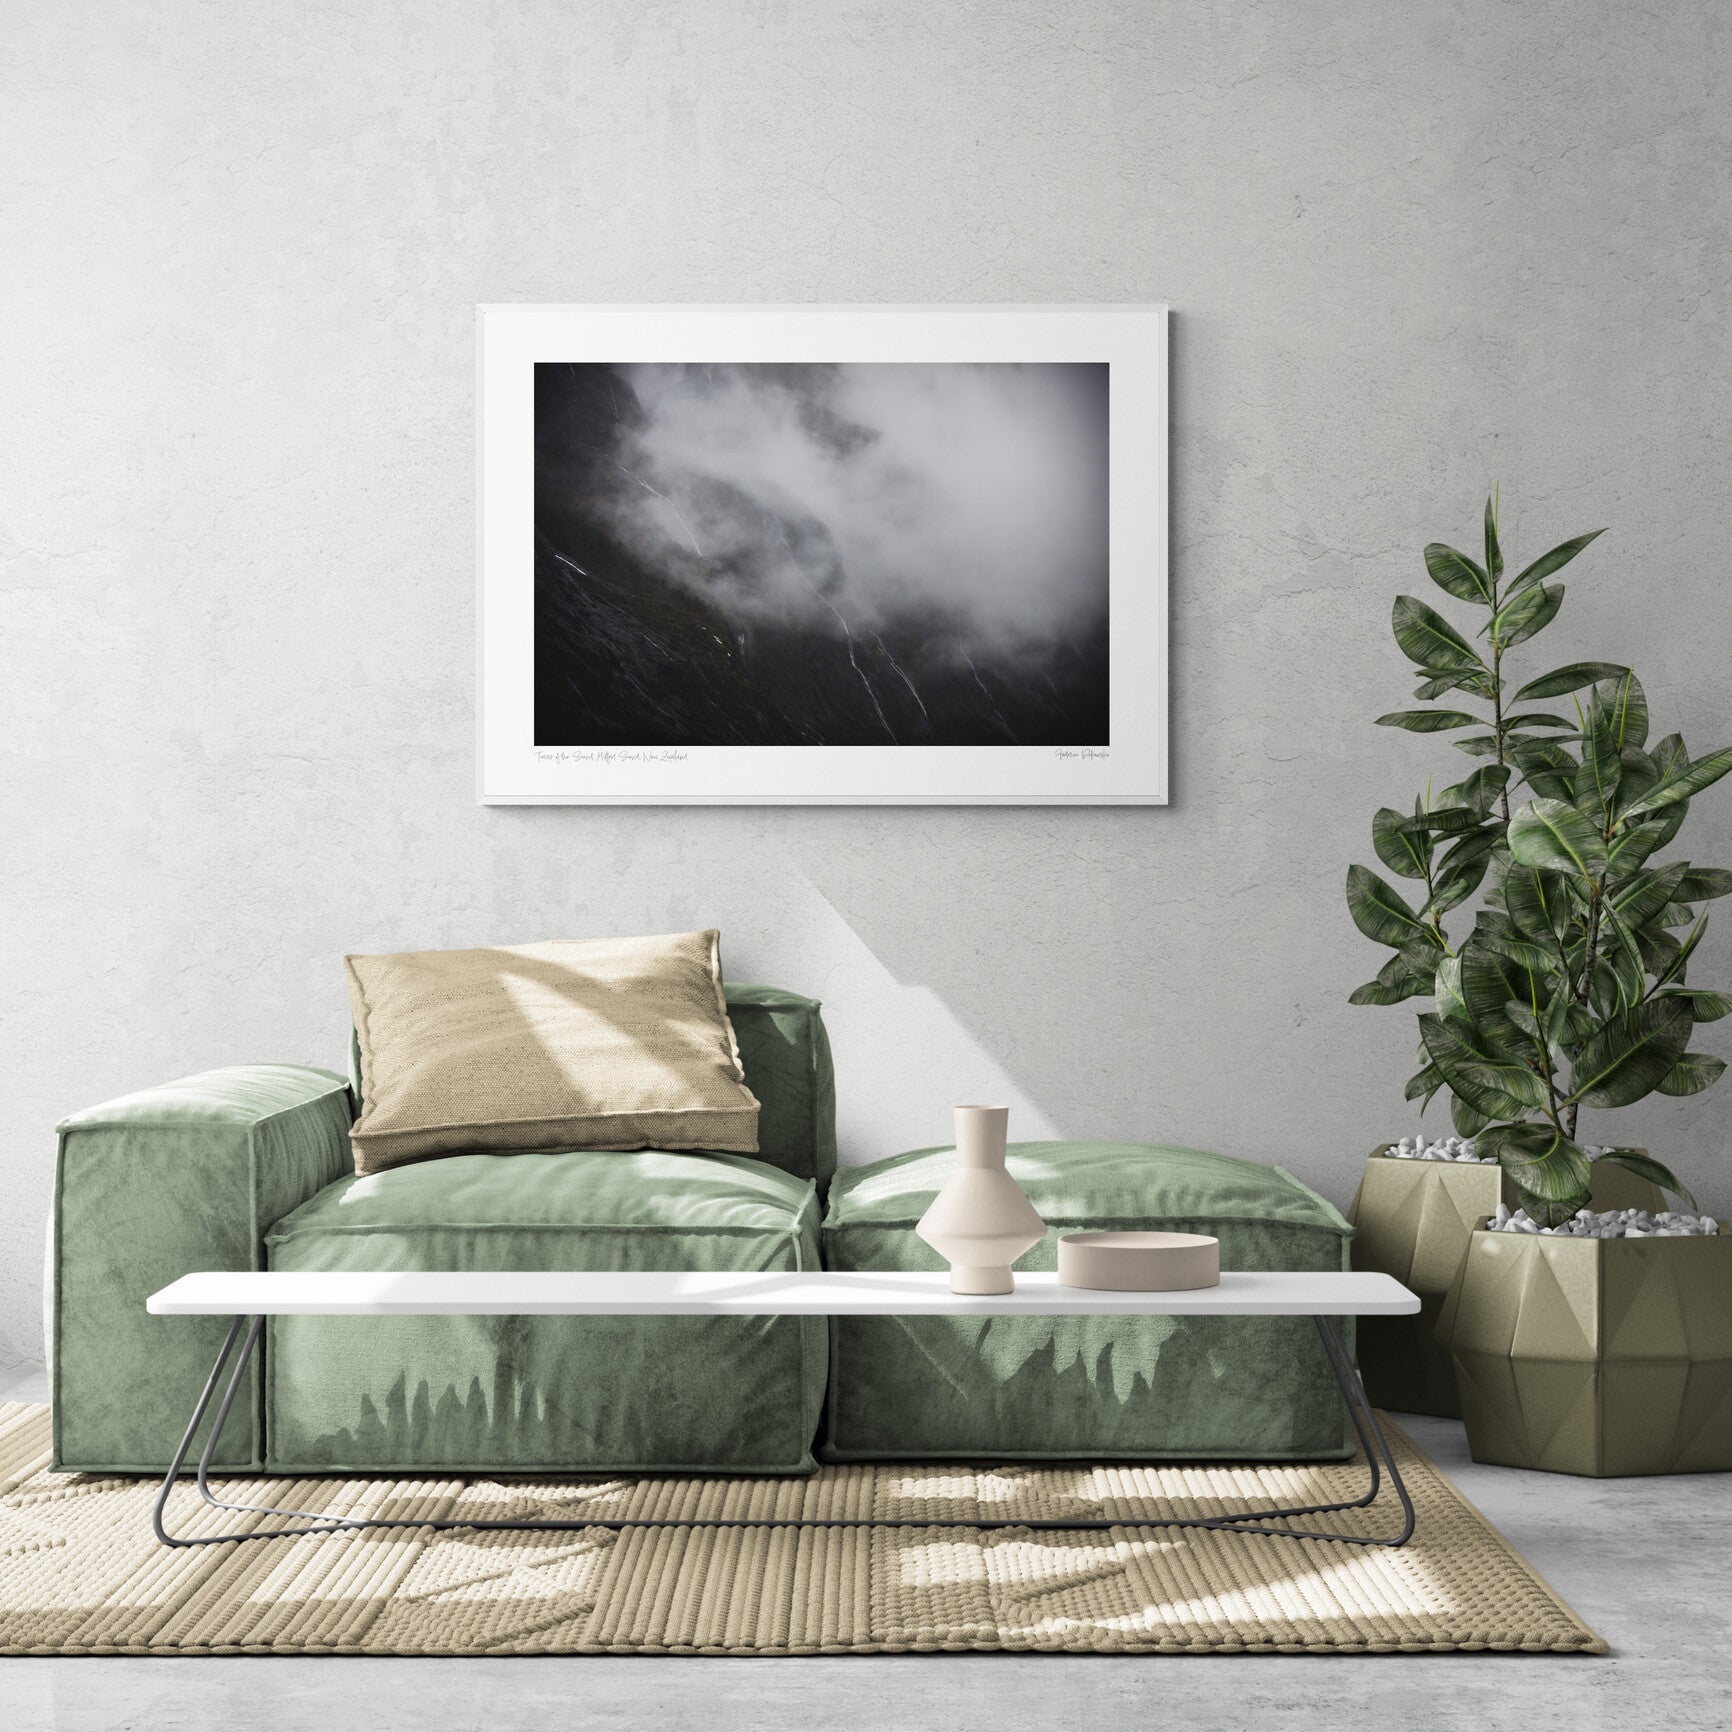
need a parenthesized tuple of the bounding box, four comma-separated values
(348, 980, 837, 1192)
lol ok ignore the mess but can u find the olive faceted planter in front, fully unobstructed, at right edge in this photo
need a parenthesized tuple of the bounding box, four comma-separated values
(1438, 1226, 1732, 1479)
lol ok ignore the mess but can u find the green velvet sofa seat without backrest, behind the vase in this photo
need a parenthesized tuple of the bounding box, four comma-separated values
(823, 1143, 1353, 1462)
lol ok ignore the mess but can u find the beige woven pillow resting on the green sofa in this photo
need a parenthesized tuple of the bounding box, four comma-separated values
(343, 932, 759, 1173)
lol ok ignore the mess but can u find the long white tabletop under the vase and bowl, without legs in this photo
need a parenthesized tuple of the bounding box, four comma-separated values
(147, 1270, 1419, 1316)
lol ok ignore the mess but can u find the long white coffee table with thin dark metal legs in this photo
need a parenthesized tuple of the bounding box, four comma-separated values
(147, 1270, 1419, 1545)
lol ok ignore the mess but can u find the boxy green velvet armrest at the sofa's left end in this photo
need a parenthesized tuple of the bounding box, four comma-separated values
(48, 1065, 353, 1472)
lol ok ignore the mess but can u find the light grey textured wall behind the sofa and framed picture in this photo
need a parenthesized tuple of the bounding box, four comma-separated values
(0, 0, 1732, 1360)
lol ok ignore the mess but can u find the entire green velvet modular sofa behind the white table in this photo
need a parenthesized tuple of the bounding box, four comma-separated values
(47, 986, 1351, 1474)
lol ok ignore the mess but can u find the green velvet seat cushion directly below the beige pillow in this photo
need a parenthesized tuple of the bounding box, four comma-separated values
(267, 1150, 824, 1474)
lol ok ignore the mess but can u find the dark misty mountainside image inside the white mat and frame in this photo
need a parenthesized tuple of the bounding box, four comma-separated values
(535, 362, 1110, 746)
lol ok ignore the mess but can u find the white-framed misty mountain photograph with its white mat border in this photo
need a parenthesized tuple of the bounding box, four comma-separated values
(478, 305, 1167, 805)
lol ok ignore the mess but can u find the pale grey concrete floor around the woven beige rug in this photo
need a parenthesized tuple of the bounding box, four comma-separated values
(0, 1373, 1732, 1732)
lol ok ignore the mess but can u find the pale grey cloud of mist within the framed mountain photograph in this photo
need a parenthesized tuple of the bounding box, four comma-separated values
(592, 364, 1107, 658)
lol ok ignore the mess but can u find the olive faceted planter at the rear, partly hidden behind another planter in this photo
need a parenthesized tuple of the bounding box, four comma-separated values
(1347, 1143, 1666, 1419)
